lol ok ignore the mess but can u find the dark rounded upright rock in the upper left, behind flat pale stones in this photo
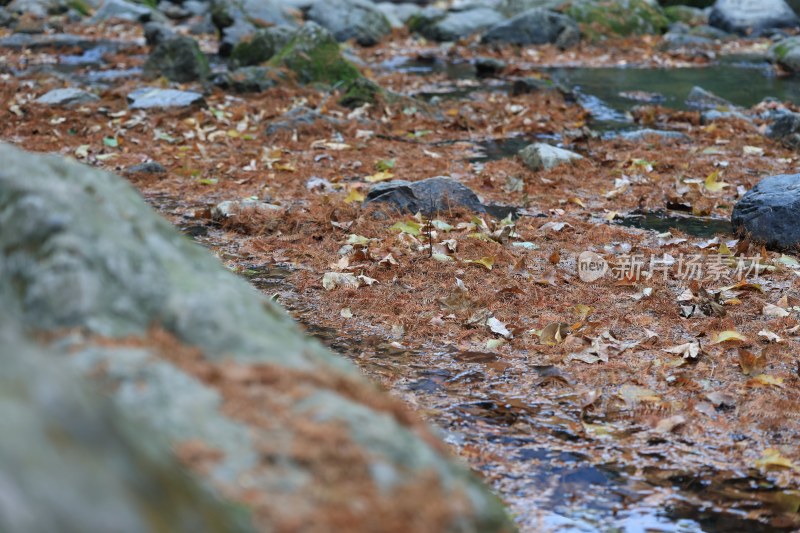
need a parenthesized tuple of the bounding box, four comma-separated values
(144, 35, 210, 83)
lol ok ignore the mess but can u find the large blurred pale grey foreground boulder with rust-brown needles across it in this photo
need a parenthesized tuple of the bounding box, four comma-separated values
(0, 141, 512, 532)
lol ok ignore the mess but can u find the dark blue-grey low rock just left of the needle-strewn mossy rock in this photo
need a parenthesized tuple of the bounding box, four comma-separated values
(482, 8, 580, 48)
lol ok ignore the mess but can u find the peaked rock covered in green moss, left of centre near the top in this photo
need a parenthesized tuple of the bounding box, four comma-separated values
(269, 22, 361, 85)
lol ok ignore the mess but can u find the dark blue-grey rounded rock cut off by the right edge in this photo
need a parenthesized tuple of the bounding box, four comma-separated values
(731, 174, 800, 250)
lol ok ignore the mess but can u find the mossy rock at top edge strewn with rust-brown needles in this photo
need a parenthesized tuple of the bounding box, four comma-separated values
(567, 0, 669, 41)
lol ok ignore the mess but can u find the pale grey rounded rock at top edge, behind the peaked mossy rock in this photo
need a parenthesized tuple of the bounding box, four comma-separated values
(308, 0, 392, 46)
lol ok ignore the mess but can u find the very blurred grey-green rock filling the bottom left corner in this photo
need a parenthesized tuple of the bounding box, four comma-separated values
(0, 316, 253, 533)
